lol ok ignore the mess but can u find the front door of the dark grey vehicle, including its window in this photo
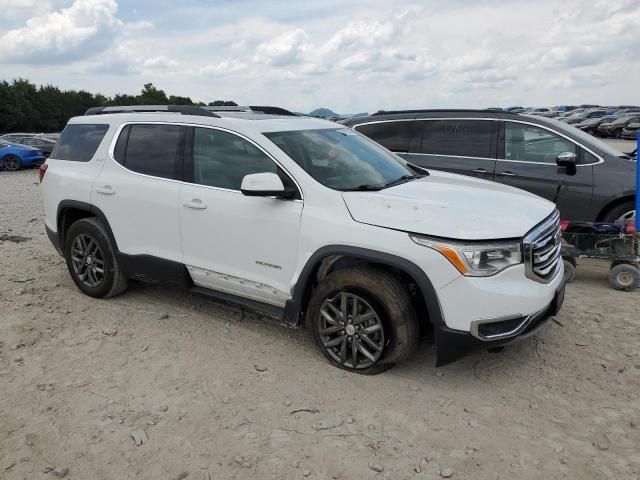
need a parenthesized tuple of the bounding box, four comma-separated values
(495, 121, 599, 221)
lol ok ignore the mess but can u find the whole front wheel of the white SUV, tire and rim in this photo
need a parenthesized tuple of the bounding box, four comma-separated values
(306, 267, 420, 374)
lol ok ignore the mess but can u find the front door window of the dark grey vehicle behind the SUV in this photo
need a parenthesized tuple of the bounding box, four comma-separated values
(504, 122, 578, 164)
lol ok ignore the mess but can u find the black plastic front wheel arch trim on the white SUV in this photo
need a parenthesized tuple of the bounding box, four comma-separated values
(285, 245, 444, 326)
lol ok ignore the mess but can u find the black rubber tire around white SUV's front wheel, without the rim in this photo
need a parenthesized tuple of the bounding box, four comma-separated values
(306, 267, 420, 375)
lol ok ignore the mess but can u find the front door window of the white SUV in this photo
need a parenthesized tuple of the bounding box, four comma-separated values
(193, 128, 278, 190)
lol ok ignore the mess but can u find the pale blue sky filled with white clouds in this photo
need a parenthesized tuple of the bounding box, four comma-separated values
(0, 0, 640, 113)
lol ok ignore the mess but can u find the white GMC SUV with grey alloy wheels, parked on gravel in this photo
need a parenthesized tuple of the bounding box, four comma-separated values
(40, 106, 564, 373)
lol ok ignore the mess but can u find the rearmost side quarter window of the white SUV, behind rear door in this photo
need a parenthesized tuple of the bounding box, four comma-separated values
(51, 124, 109, 162)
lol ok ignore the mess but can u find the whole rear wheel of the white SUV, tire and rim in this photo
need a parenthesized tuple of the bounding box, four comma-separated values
(64, 218, 127, 298)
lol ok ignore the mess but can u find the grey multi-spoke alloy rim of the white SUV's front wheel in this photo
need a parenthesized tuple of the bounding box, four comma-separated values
(317, 292, 385, 369)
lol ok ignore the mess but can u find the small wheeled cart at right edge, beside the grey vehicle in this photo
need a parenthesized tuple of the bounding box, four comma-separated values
(562, 231, 640, 291)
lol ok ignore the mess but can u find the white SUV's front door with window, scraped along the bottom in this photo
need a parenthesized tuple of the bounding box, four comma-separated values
(180, 127, 303, 306)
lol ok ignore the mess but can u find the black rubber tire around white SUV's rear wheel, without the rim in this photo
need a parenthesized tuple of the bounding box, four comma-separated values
(64, 218, 127, 298)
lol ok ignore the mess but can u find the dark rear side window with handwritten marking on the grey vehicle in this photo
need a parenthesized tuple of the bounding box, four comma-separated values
(418, 120, 497, 158)
